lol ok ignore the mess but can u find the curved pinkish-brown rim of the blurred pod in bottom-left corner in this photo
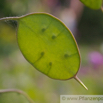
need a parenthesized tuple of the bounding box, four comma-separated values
(0, 89, 34, 103)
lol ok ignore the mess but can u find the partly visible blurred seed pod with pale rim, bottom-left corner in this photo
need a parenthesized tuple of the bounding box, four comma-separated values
(0, 89, 34, 103)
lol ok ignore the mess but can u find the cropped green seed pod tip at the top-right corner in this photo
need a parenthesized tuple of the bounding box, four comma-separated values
(80, 0, 102, 9)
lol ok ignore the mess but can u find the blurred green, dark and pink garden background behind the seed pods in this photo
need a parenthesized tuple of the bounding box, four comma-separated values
(0, 0, 103, 103)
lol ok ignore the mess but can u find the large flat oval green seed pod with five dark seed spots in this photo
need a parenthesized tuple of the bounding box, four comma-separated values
(17, 13, 80, 80)
